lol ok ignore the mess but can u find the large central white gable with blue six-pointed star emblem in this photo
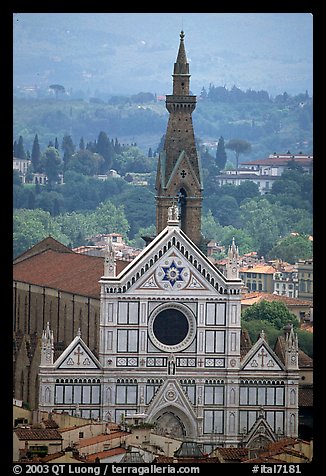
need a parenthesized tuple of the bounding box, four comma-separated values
(100, 226, 241, 296)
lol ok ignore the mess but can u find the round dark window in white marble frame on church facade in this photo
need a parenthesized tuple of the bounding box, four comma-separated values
(148, 303, 196, 352)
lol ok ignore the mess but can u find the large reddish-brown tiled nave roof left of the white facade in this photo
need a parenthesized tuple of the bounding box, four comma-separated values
(13, 249, 129, 298)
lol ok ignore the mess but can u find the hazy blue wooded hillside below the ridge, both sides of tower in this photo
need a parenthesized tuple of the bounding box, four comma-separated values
(13, 86, 313, 160)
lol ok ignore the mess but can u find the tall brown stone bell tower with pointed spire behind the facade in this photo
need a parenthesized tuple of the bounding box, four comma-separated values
(156, 31, 203, 246)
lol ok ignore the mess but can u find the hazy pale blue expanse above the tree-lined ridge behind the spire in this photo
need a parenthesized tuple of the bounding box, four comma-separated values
(13, 13, 313, 95)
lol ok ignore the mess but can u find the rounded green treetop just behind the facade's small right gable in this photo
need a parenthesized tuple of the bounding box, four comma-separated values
(242, 300, 300, 330)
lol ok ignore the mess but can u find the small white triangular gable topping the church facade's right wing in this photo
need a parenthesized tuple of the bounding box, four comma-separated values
(241, 337, 284, 372)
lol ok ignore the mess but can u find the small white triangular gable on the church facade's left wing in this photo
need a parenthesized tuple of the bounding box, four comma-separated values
(54, 336, 101, 371)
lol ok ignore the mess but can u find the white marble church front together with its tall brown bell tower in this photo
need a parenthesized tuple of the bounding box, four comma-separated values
(39, 32, 299, 450)
